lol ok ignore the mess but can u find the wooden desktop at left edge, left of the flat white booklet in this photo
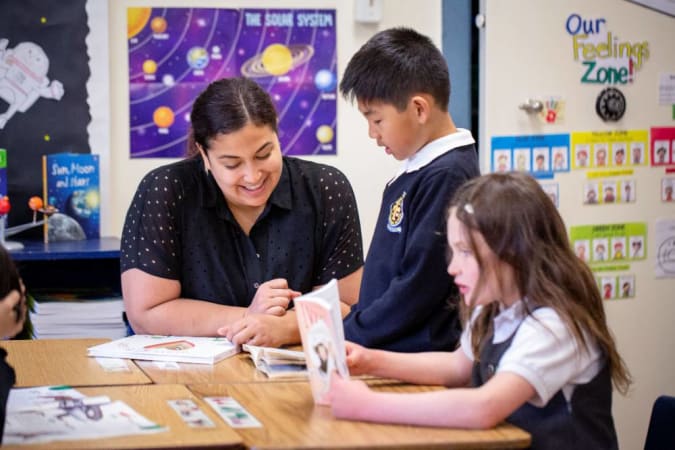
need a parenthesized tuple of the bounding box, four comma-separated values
(0, 339, 152, 387)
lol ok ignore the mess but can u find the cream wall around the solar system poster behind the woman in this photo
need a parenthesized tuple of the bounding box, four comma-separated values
(101, 0, 441, 249)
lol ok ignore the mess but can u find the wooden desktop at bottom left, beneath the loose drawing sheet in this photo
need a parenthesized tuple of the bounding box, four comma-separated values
(2, 384, 242, 450)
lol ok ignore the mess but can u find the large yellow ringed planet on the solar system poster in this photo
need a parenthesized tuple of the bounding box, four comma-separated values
(241, 44, 314, 78)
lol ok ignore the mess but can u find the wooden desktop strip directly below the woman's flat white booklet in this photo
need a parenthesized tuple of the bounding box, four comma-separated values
(134, 352, 305, 384)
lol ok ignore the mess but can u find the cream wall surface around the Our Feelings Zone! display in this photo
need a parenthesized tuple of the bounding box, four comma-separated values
(480, 0, 675, 450)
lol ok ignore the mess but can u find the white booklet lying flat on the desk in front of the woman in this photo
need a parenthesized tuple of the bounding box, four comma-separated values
(87, 334, 239, 364)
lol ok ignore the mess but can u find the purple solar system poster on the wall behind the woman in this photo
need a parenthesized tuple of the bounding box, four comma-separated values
(127, 8, 337, 158)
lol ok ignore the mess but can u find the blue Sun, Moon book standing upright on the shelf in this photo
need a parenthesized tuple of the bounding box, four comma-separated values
(42, 153, 101, 242)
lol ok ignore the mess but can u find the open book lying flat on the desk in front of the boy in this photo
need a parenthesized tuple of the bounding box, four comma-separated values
(241, 344, 307, 378)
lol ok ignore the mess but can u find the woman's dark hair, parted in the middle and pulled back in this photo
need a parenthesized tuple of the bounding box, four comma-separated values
(188, 77, 278, 155)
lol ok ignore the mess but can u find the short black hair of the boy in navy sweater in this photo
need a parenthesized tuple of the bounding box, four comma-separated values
(340, 27, 450, 111)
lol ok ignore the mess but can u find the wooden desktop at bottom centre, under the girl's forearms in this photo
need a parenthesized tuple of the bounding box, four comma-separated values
(188, 381, 530, 449)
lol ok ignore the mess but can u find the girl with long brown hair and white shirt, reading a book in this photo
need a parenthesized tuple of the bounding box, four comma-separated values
(331, 172, 630, 450)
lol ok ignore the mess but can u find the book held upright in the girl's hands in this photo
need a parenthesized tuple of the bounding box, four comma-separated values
(294, 279, 349, 405)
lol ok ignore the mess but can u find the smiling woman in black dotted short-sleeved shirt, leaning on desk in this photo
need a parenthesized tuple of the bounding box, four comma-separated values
(121, 78, 363, 346)
